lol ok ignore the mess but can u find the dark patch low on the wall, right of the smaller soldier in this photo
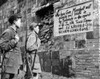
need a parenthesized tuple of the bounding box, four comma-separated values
(39, 51, 76, 78)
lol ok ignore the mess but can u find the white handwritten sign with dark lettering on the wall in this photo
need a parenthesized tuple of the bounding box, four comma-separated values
(54, 2, 93, 36)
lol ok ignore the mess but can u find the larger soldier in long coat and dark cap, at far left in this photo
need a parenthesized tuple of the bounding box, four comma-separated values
(0, 14, 22, 79)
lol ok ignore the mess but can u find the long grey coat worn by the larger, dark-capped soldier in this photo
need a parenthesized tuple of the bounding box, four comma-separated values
(0, 27, 22, 74)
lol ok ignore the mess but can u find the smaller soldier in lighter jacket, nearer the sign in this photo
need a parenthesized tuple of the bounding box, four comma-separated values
(27, 23, 41, 79)
